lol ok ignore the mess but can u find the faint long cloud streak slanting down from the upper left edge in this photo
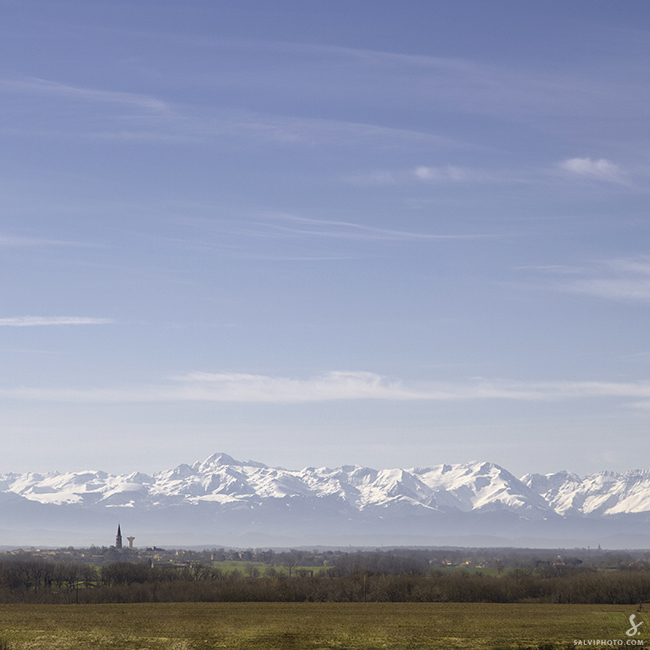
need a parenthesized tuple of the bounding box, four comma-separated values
(0, 78, 460, 148)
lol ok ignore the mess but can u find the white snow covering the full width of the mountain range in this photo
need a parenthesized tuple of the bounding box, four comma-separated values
(0, 454, 650, 520)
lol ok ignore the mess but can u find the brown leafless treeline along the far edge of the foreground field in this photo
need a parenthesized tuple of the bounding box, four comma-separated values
(0, 560, 650, 604)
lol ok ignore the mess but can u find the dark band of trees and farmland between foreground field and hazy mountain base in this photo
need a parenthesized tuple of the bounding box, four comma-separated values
(6, 549, 650, 604)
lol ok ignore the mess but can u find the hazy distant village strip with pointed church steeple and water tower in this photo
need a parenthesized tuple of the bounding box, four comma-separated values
(0, 524, 624, 577)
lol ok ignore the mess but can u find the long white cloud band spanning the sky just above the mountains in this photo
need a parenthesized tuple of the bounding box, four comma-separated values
(0, 371, 650, 406)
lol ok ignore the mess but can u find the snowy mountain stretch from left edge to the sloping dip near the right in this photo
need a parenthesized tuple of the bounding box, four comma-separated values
(0, 454, 549, 516)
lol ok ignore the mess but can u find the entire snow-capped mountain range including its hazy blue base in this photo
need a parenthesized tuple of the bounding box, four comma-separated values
(0, 454, 650, 547)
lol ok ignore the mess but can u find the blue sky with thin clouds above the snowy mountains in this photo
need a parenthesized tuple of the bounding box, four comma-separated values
(0, 0, 650, 475)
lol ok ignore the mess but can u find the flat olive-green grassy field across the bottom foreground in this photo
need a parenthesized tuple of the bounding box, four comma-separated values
(0, 603, 650, 650)
